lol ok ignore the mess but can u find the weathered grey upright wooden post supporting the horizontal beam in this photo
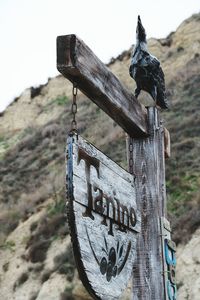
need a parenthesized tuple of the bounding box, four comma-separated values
(127, 107, 166, 300)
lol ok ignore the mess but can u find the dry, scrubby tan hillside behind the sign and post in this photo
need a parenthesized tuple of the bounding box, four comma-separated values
(0, 14, 200, 300)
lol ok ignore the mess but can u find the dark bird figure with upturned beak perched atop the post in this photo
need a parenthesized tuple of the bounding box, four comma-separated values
(129, 16, 168, 109)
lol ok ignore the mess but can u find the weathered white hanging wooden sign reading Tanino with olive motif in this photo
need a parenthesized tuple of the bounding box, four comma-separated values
(67, 134, 141, 300)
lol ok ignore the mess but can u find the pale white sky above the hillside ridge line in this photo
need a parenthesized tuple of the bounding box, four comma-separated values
(0, 0, 200, 111)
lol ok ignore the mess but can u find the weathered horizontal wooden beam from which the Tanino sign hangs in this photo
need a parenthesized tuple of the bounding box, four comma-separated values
(57, 34, 147, 138)
